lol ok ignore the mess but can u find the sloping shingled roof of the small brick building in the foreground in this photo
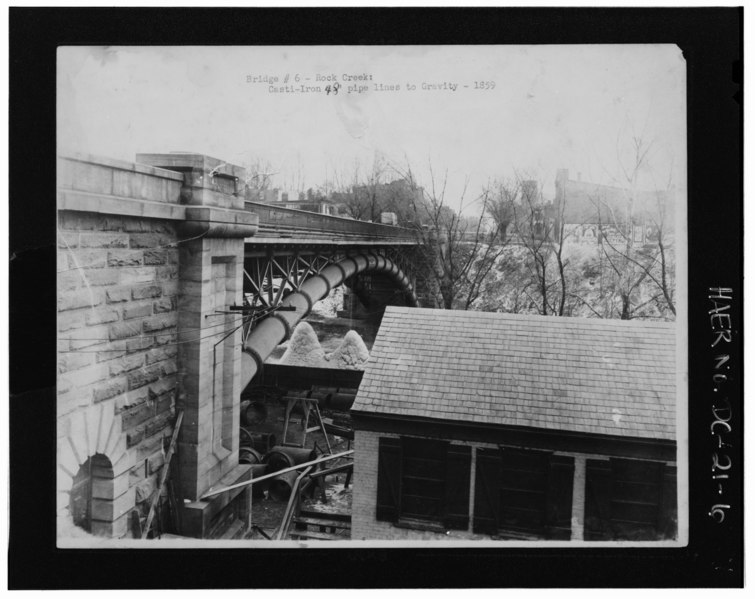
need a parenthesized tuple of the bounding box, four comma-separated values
(352, 307, 676, 440)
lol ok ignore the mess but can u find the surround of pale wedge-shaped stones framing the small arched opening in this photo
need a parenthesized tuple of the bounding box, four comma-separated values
(57, 402, 136, 537)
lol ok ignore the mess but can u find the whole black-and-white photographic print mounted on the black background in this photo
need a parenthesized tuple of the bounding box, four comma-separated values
(57, 44, 686, 547)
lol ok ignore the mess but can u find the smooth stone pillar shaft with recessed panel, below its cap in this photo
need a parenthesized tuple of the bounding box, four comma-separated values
(178, 239, 244, 501)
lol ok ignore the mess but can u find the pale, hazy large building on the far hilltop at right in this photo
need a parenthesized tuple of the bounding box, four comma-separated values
(554, 169, 675, 245)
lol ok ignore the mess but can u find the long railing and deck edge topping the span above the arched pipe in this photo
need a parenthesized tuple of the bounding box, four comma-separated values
(244, 202, 417, 242)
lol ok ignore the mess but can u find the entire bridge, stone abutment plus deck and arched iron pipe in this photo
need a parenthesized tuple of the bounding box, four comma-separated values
(57, 153, 426, 538)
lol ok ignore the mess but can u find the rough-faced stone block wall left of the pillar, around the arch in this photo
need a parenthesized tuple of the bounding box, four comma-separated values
(57, 211, 178, 536)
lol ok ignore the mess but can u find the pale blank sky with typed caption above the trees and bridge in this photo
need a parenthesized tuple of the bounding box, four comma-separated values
(58, 45, 686, 213)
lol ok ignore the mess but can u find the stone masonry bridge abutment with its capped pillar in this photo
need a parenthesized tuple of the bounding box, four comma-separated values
(57, 154, 257, 537)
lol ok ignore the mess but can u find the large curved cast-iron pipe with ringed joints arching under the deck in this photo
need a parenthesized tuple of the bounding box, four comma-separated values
(241, 252, 419, 389)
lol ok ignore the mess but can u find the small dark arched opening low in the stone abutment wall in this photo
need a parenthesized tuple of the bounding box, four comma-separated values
(69, 453, 113, 534)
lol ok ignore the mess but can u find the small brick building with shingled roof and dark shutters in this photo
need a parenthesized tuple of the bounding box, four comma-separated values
(351, 307, 678, 541)
